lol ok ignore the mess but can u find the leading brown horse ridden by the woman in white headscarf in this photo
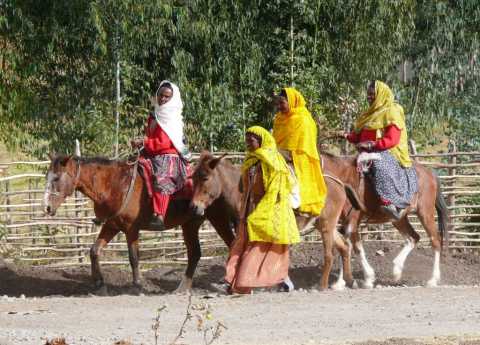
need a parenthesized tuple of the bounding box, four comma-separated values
(44, 156, 234, 292)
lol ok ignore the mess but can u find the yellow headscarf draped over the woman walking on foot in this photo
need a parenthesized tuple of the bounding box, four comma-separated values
(242, 126, 300, 244)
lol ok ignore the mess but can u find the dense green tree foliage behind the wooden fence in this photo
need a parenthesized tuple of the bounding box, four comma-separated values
(0, 0, 480, 155)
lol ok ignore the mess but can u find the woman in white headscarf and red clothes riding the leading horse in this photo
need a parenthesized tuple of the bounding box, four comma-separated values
(131, 80, 189, 228)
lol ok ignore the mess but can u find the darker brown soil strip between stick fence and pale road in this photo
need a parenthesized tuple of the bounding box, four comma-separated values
(0, 242, 480, 297)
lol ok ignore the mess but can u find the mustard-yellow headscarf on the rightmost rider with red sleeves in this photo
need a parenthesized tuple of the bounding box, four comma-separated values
(354, 80, 412, 168)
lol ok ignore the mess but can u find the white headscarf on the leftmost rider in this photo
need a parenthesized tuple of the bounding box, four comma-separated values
(151, 80, 187, 155)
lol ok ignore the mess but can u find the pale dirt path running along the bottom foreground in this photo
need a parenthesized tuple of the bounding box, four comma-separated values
(0, 287, 480, 345)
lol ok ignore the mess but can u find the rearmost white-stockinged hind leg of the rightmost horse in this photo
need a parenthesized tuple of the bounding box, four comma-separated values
(417, 205, 441, 287)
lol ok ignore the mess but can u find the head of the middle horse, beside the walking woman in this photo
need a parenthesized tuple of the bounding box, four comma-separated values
(191, 151, 225, 215)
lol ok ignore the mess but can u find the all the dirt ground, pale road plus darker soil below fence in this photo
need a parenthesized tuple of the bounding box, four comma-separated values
(0, 243, 480, 345)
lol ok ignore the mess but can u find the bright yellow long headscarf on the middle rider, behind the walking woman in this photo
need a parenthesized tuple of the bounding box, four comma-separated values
(273, 88, 327, 215)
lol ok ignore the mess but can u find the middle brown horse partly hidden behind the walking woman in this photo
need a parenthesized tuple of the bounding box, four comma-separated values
(192, 151, 354, 290)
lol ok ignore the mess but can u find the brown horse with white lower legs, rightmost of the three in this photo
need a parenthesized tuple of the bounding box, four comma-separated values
(321, 153, 448, 287)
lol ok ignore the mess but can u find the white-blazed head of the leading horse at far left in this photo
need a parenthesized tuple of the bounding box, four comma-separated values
(43, 156, 80, 216)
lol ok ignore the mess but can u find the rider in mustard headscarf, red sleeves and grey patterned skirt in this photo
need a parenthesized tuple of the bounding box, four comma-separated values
(344, 80, 418, 220)
